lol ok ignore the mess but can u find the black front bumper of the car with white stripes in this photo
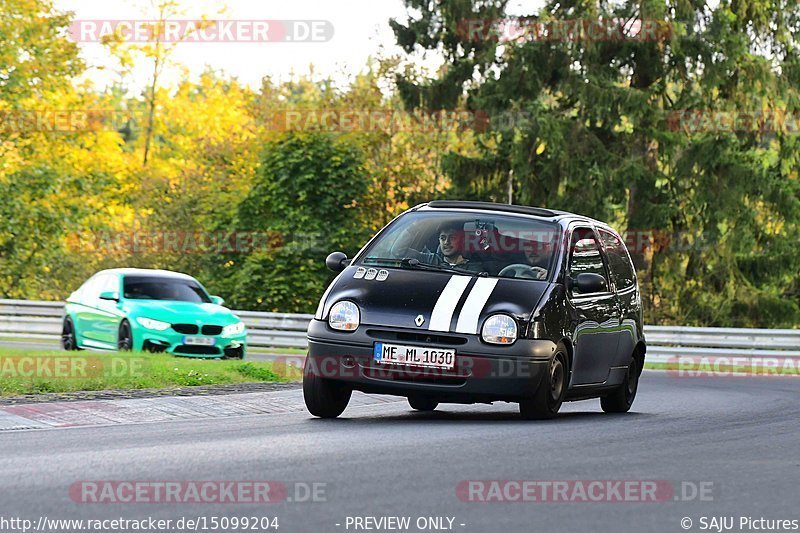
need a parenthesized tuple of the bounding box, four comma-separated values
(305, 319, 556, 402)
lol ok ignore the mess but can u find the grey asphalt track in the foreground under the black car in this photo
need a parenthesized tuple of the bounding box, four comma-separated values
(0, 372, 800, 532)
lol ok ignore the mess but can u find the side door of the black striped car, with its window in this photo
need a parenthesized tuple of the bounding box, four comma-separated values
(567, 226, 620, 385)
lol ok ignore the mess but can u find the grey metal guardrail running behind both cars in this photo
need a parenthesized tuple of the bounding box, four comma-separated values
(0, 300, 800, 363)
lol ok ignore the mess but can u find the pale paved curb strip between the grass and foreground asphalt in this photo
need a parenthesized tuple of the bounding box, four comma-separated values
(0, 389, 399, 431)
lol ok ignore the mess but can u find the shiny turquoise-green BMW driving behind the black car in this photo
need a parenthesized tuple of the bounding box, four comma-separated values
(61, 268, 247, 359)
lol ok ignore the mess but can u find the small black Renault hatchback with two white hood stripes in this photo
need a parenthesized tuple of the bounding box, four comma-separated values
(303, 201, 646, 418)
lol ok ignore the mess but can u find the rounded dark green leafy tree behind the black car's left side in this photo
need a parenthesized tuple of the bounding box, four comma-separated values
(229, 133, 369, 312)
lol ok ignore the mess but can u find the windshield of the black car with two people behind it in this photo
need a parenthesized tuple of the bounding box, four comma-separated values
(359, 211, 560, 280)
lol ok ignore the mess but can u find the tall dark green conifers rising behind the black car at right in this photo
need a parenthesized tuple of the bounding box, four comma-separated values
(394, 0, 800, 326)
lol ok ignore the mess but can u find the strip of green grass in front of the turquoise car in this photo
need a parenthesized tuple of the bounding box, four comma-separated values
(0, 348, 297, 396)
